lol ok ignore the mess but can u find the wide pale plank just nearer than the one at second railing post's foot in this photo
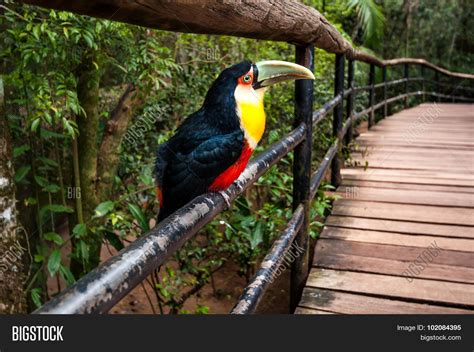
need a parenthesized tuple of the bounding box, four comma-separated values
(332, 199, 474, 226)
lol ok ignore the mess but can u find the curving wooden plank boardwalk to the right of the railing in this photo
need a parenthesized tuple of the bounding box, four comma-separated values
(296, 104, 474, 314)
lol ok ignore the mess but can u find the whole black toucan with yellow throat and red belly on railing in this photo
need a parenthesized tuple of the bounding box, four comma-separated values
(155, 60, 314, 221)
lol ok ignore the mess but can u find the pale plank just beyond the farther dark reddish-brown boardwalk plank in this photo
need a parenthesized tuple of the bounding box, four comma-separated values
(320, 226, 474, 252)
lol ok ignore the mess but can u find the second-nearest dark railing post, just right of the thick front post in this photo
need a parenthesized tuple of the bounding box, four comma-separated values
(331, 54, 344, 187)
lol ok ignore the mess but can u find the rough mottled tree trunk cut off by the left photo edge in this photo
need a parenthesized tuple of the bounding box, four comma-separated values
(0, 77, 27, 314)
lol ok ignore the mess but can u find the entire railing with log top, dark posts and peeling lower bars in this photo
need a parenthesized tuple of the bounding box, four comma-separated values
(25, 0, 474, 314)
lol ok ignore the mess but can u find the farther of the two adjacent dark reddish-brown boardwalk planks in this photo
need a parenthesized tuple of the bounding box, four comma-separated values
(315, 239, 474, 268)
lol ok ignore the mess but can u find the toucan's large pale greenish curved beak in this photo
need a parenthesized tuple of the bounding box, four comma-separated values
(253, 60, 314, 89)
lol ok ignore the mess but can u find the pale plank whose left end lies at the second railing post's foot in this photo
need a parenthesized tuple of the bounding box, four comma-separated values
(336, 186, 474, 208)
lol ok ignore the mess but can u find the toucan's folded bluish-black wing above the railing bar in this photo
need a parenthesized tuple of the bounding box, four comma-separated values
(155, 124, 244, 220)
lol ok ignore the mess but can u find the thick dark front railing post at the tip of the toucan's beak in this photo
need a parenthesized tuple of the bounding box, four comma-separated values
(290, 45, 314, 312)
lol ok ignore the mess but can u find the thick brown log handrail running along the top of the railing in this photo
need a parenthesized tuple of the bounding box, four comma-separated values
(24, 0, 474, 79)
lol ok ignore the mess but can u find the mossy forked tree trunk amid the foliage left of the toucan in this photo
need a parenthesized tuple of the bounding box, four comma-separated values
(71, 54, 142, 277)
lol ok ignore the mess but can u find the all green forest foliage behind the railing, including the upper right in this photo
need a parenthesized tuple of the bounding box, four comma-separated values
(4, 0, 466, 314)
